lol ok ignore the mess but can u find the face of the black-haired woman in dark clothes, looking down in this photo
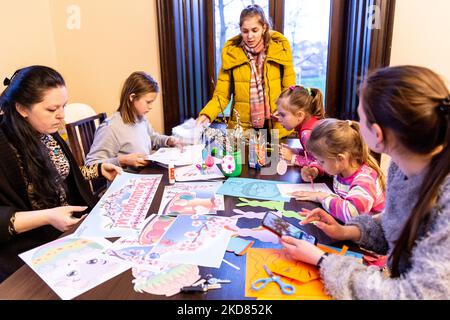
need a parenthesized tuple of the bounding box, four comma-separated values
(16, 86, 68, 134)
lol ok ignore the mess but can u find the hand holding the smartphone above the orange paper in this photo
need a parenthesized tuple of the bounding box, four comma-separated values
(281, 236, 324, 265)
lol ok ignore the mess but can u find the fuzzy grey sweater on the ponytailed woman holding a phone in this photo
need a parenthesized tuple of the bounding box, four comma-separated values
(320, 163, 450, 300)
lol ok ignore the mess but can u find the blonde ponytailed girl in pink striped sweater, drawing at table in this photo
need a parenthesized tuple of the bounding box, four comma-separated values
(294, 119, 385, 222)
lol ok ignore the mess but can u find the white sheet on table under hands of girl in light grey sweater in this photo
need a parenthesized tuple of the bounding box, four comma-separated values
(146, 144, 204, 166)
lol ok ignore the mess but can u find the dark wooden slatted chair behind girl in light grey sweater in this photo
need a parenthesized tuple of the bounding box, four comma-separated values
(66, 112, 106, 197)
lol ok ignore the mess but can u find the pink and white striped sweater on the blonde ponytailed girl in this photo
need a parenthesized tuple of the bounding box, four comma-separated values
(322, 164, 385, 222)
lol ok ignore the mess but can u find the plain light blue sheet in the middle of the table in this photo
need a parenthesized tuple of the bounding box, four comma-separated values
(217, 178, 290, 202)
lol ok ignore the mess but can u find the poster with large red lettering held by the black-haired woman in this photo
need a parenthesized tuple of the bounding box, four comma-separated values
(75, 172, 162, 238)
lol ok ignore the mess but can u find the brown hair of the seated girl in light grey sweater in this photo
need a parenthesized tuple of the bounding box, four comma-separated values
(117, 71, 159, 124)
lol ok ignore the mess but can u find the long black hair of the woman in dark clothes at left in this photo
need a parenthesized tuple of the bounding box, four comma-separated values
(0, 66, 65, 208)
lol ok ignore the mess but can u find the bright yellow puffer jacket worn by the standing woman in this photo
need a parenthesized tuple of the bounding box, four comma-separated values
(200, 31, 296, 137)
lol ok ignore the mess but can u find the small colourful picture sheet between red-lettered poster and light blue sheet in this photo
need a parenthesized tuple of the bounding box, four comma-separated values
(158, 181, 225, 215)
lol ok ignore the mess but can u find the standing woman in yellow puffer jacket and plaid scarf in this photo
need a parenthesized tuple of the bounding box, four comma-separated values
(197, 5, 296, 137)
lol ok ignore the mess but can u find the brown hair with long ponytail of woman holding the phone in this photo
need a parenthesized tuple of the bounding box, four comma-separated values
(360, 66, 450, 277)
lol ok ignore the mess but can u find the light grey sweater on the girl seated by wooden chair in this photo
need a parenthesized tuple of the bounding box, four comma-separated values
(85, 112, 169, 166)
